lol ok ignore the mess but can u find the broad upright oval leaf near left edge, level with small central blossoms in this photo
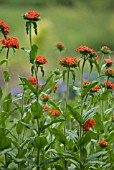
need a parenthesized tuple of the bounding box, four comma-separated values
(2, 93, 12, 112)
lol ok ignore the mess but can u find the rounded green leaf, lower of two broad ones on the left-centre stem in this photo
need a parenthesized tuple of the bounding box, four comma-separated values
(33, 136, 47, 149)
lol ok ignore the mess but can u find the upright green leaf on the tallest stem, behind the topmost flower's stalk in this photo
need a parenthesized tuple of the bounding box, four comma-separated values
(30, 44, 38, 64)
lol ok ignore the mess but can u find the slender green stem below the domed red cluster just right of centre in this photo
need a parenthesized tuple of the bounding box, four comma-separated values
(64, 67, 70, 168)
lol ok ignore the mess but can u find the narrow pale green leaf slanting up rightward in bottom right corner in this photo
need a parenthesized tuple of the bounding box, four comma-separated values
(85, 151, 107, 163)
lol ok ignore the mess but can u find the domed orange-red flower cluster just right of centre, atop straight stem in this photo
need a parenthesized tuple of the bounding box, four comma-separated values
(59, 56, 78, 68)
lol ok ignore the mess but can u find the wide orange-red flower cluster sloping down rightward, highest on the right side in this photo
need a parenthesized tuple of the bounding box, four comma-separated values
(76, 46, 98, 60)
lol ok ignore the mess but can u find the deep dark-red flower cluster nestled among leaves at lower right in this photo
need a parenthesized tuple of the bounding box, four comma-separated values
(82, 119, 96, 131)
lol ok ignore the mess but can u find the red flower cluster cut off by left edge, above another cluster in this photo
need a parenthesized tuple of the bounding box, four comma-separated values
(0, 20, 10, 35)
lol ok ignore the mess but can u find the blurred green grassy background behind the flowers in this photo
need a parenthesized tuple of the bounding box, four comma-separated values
(0, 0, 114, 87)
